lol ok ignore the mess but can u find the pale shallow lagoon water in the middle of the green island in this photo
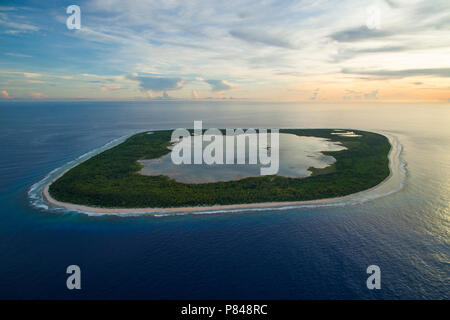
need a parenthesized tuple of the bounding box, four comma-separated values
(139, 133, 345, 183)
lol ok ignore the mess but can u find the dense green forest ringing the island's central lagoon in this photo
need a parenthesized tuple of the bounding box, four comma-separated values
(49, 129, 390, 208)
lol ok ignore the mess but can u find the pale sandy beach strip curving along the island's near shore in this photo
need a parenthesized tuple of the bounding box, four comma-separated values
(42, 134, 397, 214)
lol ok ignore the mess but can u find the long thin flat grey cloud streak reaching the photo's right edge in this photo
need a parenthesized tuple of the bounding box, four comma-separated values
(342, 68, 450, 78)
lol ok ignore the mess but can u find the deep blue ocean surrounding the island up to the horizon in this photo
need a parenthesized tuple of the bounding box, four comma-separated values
(0, 101, 450, 299)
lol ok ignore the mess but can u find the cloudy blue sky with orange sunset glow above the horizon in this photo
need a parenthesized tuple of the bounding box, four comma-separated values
(0, 0, 450, 103)
